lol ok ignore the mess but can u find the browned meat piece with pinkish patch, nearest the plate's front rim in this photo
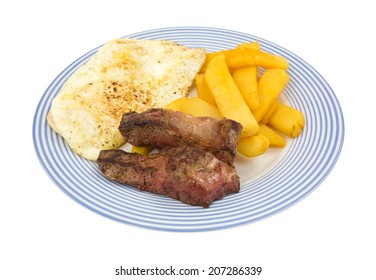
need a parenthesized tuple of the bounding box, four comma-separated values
(98, 146, 240, 207)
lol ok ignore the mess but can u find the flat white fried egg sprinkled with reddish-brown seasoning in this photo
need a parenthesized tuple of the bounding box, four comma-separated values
(47, 38, 206, 160)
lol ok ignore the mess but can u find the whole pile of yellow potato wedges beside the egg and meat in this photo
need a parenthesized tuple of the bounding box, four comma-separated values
(133, 42, 305, 160)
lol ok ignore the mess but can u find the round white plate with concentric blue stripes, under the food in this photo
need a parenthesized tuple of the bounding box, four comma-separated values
(33, 27, 344, 231)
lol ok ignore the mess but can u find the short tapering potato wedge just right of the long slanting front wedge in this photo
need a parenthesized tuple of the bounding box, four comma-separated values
(232, 66, 259, 111)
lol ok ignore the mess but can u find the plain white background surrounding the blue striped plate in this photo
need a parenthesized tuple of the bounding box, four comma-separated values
(0, 0, 376, 280)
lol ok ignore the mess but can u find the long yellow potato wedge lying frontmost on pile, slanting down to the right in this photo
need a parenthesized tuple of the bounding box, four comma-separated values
(205, 54, 259, 138)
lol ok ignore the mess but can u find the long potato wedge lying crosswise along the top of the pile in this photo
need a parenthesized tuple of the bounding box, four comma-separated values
(200, 47, 289, 73)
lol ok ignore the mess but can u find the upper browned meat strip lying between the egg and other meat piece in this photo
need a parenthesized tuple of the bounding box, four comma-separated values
(119, 109, 242, 164)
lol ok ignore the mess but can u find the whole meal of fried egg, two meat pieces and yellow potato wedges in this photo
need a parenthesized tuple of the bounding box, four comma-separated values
(48, 38, 305, 207)
